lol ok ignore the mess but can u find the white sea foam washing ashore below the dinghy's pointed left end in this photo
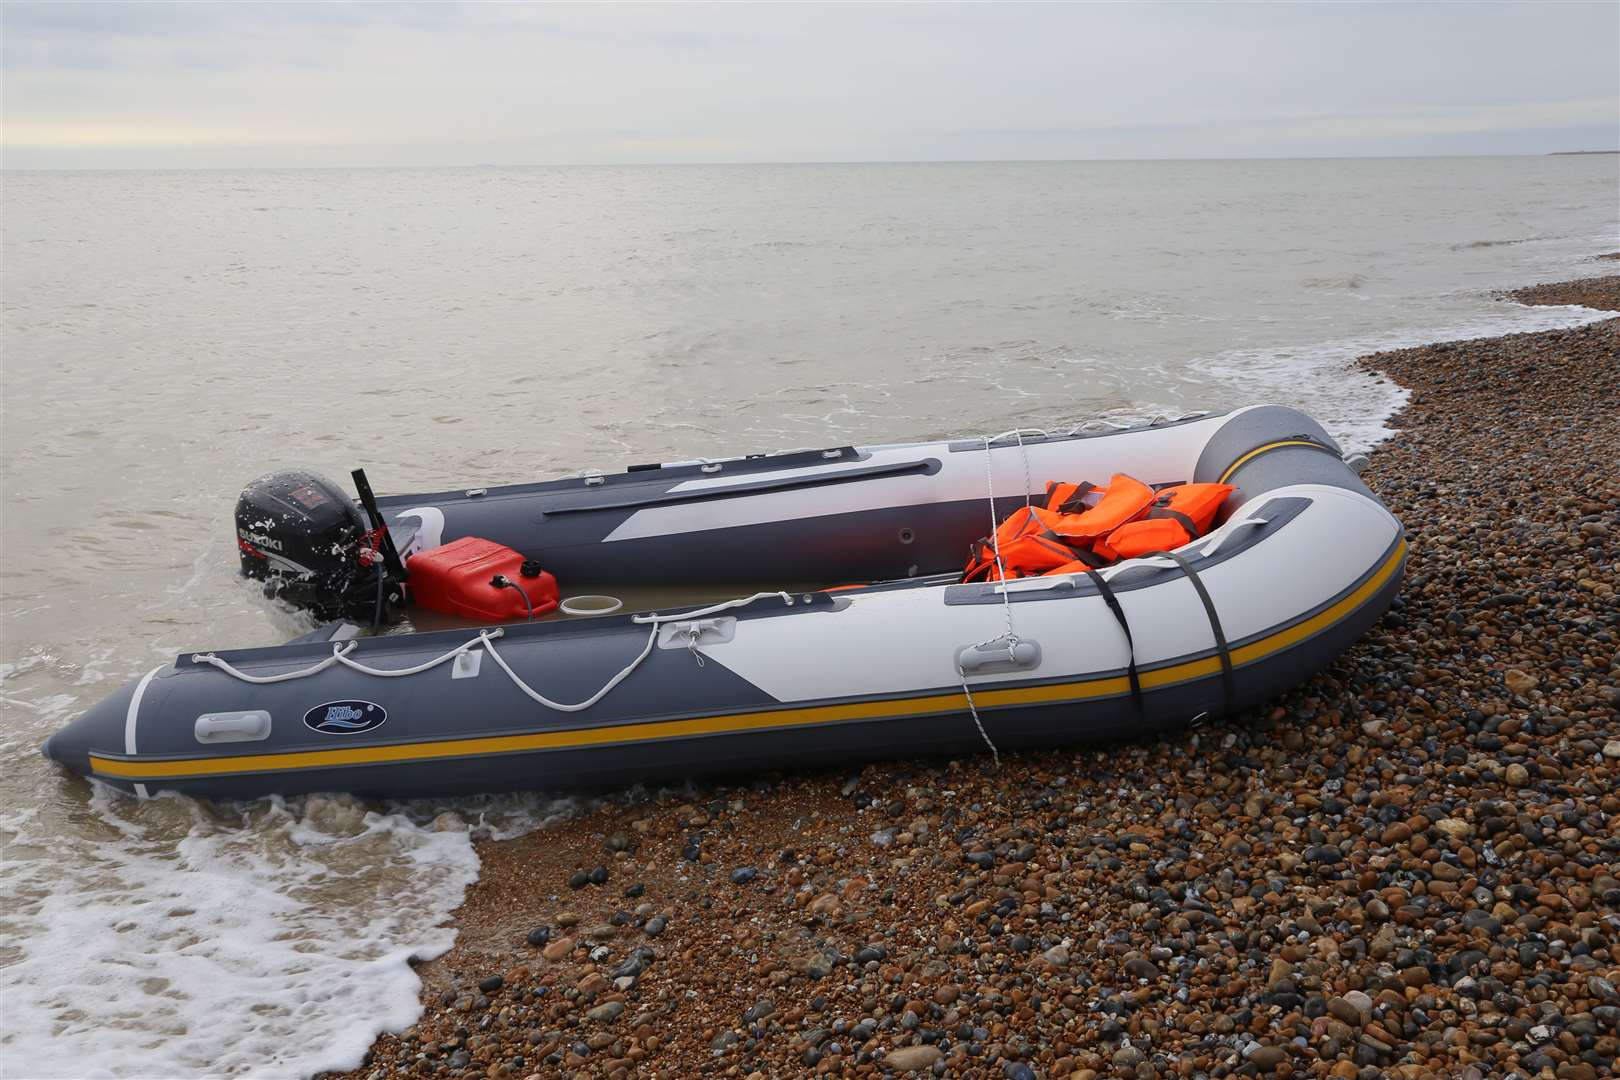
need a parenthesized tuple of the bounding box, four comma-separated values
(0, 789, 478, 1077)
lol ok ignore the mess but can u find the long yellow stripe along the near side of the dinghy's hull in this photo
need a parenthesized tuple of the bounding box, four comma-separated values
(91, 540, 1406, 780)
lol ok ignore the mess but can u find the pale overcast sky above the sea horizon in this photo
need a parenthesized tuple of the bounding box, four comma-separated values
(0, 0, 1620, 168)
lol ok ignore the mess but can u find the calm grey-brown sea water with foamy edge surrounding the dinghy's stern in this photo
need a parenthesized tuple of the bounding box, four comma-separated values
(0, 157, 1620, 1077)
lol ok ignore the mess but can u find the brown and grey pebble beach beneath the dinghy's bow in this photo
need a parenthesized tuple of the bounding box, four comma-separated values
(335, 272, 1620, 1080)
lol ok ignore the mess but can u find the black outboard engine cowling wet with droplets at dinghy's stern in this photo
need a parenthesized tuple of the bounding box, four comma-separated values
(237, 470, 387, 622)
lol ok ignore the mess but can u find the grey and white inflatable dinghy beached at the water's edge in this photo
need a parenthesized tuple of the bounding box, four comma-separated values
(44, 406, 1406, 798)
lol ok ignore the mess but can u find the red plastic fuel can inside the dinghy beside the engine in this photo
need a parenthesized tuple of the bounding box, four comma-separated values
(405, 536, 557, 622)
